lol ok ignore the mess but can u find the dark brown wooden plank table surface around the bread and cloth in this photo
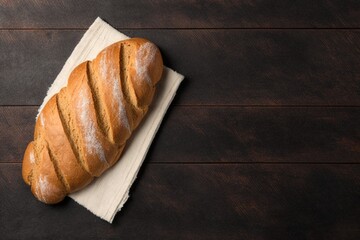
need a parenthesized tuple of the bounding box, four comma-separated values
(0, 0, 360, 239)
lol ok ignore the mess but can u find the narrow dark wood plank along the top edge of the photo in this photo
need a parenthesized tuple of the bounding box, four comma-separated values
(0, 0, 360, 28)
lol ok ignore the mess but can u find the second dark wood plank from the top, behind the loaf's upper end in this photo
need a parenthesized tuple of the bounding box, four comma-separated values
(0, 30, 360, 105)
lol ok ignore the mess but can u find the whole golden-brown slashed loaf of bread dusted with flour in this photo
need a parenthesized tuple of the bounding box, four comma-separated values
(22, 38, 163, 204)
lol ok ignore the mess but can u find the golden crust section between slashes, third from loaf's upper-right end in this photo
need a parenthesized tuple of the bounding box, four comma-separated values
(58, 62, 114, 177)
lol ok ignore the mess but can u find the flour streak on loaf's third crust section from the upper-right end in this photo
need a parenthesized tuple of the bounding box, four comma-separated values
(77, 88, 106, 163)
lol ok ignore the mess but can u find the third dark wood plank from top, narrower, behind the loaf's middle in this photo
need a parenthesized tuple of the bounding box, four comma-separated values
(0, 106, 360, 163)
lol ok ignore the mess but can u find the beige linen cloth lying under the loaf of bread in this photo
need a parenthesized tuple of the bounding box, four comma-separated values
(39, 18, 184, 223)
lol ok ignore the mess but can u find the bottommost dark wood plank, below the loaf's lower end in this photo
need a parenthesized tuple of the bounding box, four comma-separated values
(0, 164, 360, 239)
